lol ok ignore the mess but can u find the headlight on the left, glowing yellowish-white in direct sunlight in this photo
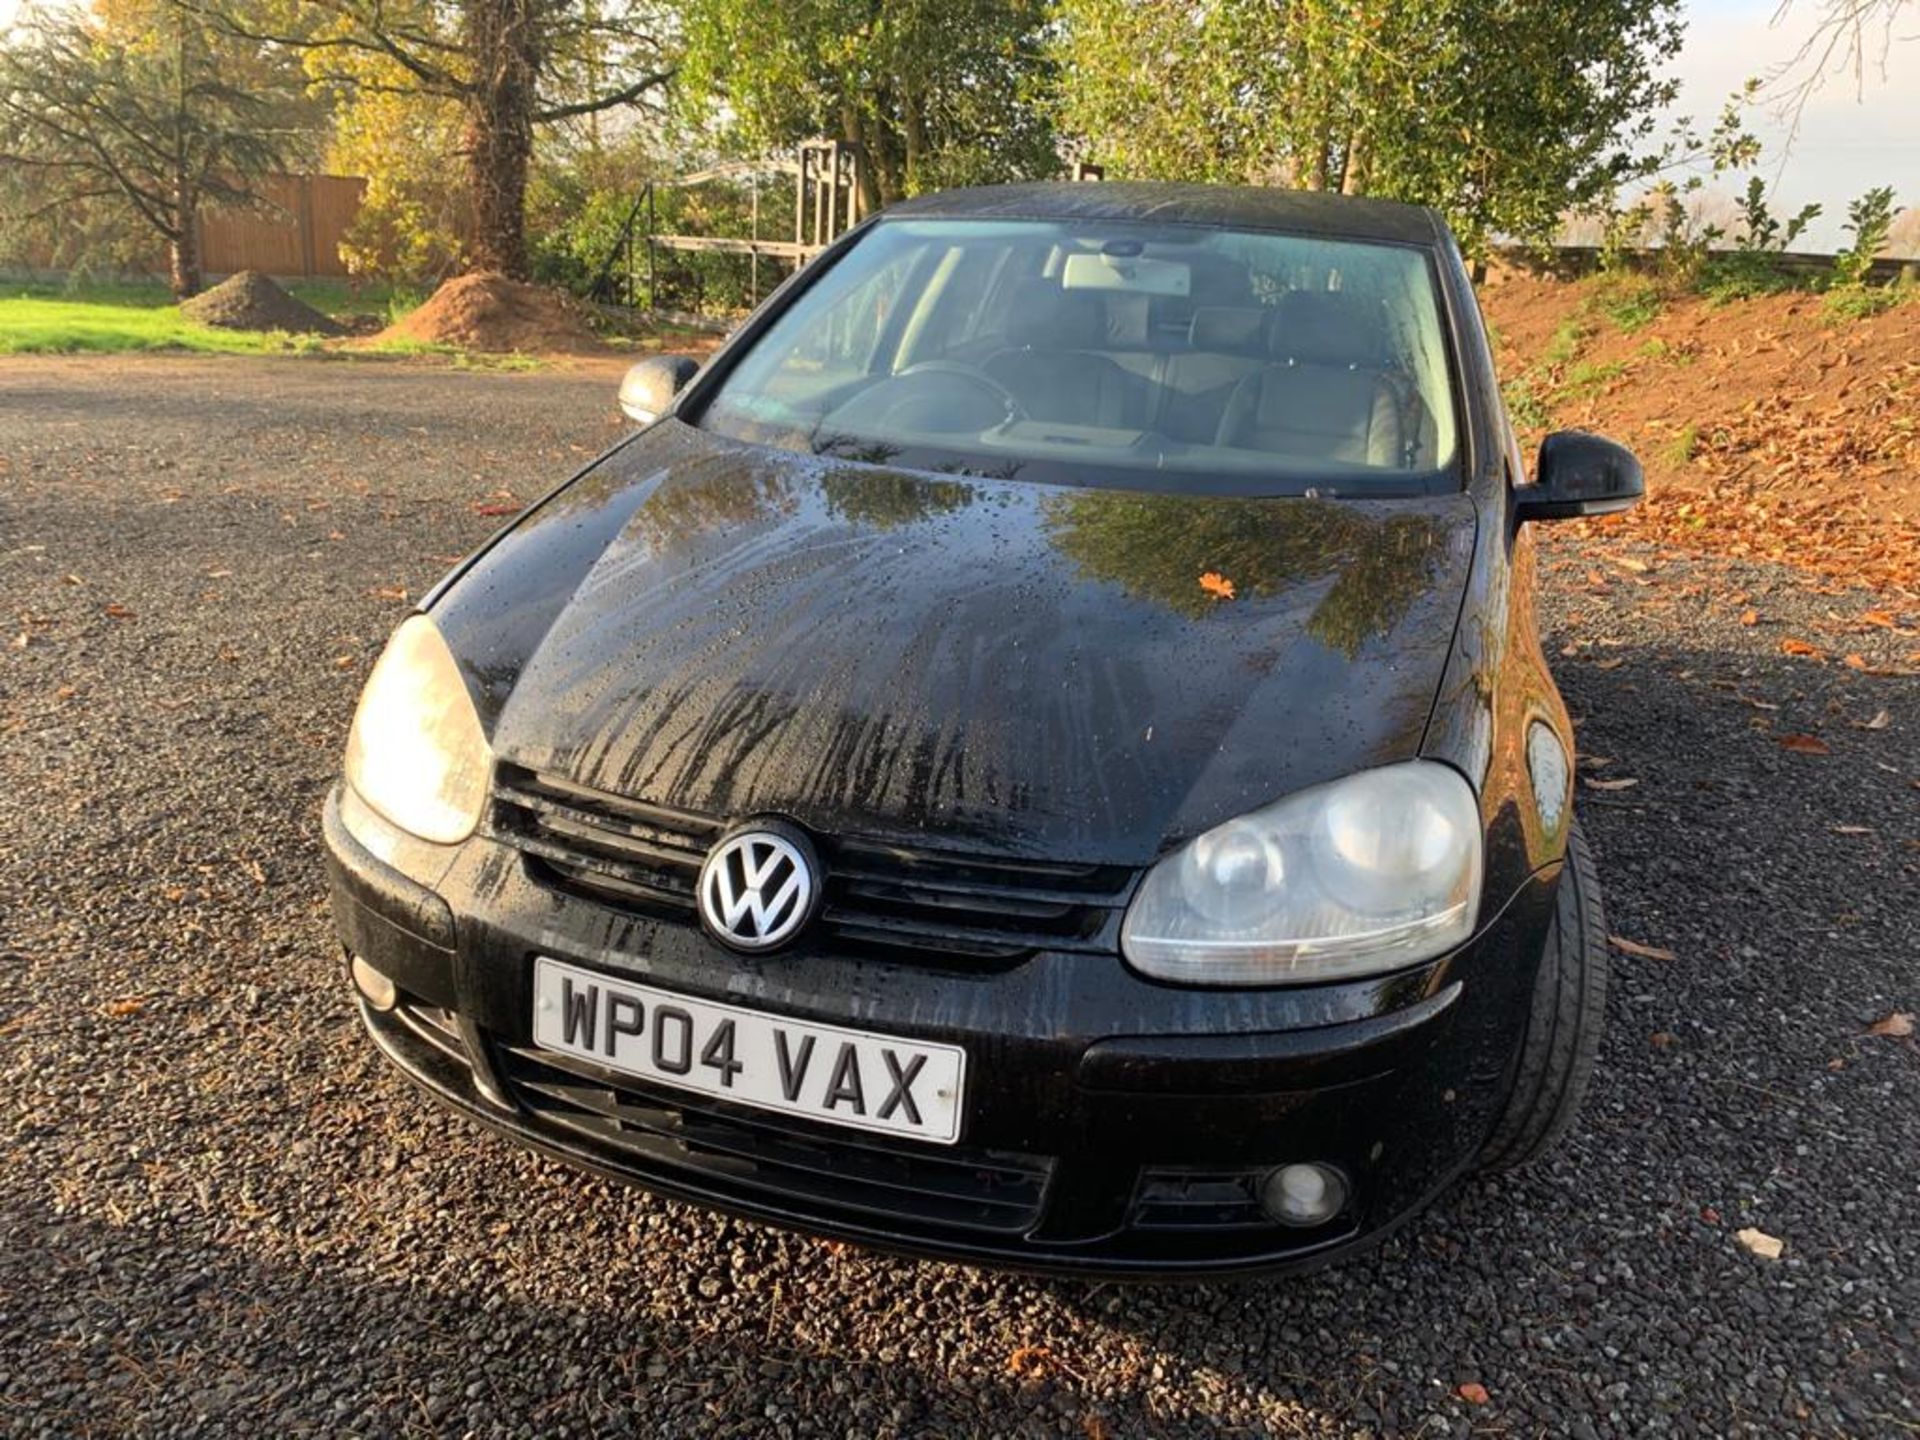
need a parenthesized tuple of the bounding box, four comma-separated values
(348, 614, 493, 845)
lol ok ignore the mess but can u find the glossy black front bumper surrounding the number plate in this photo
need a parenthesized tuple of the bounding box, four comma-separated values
(324, 787, 1557, 1277)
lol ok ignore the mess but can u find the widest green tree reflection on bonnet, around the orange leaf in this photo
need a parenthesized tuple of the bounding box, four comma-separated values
(1043, 492, 1442, 657)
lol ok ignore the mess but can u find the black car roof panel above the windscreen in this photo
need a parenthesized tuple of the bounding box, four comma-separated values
(883, 180, 1446, 246)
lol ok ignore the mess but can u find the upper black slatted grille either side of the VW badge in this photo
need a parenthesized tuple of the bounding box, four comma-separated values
(493, 766, 1135, 966)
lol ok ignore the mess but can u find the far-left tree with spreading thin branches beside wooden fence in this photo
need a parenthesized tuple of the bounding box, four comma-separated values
(0, 2, 311, 300)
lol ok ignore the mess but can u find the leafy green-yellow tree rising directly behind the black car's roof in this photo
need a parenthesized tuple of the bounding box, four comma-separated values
(1056, 0, 1682, 252)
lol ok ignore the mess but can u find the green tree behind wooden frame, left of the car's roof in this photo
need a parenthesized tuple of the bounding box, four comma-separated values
(682, 0, 1058, 209)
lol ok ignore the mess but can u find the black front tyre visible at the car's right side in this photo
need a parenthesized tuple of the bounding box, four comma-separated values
(1480, 826, 1607, 1169)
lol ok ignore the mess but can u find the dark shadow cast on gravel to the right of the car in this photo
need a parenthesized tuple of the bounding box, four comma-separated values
(1052, 645, 1920, 1434)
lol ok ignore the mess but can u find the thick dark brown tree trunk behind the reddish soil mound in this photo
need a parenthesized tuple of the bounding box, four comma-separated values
(467, 0, 540, 280)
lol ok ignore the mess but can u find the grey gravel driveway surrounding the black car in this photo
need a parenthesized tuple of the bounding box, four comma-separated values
(0, 359, 1920, 1440)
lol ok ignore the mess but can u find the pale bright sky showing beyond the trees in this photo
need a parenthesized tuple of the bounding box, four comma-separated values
(0, 0, 1920, 250)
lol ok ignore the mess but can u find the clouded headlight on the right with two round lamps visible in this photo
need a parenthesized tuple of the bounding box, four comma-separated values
(1119, 760, 1482, 985)
